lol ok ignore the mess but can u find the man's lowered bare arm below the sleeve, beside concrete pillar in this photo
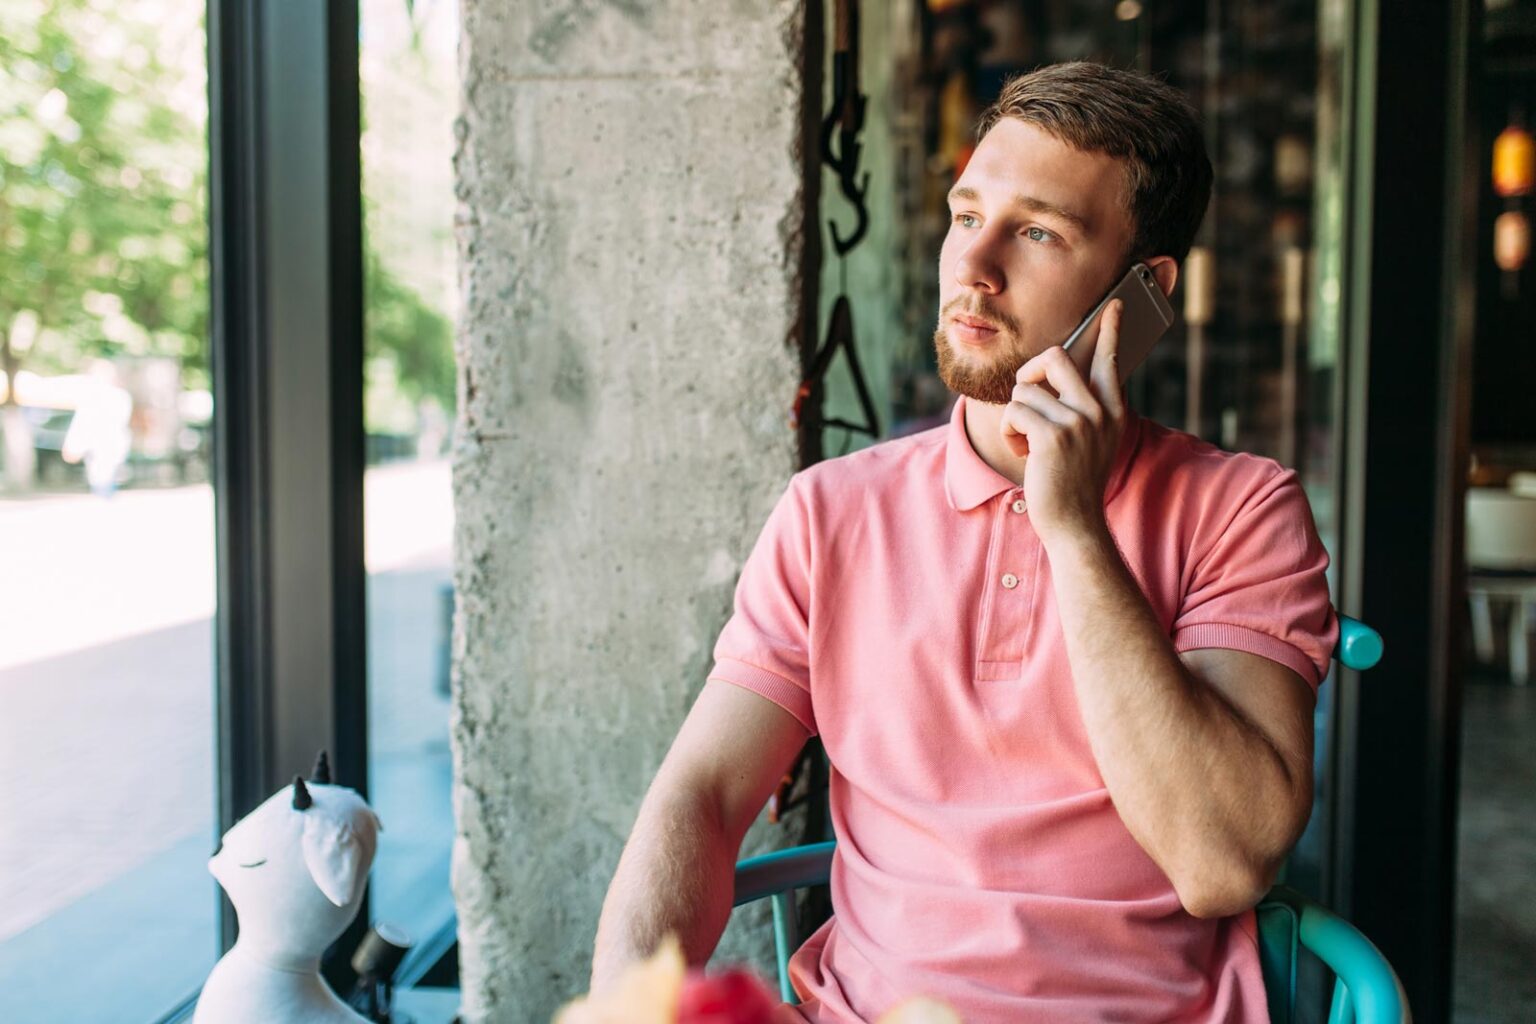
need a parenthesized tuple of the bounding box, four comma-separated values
(591, 682, 809, 992)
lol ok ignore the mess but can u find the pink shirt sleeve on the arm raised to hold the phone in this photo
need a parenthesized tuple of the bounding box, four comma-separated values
(1174, 470, 1338, 689)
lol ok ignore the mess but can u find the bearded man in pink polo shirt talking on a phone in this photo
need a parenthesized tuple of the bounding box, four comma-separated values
(593, 63, 1338, 1024)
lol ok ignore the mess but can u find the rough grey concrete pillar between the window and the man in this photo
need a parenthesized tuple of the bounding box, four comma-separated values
(453, 0, 805, 1024)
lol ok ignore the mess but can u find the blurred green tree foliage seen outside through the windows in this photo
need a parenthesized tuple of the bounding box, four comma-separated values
(0, 0, 453, 423)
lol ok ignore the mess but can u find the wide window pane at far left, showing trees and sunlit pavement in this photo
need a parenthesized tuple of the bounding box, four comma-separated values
(0, 0, 218, 1024)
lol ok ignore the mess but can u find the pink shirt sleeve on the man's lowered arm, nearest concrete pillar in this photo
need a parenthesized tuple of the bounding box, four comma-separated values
(710, 474, 816, 735)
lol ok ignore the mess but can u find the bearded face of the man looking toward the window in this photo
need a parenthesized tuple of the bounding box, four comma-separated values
(934, 117, 1134, 404)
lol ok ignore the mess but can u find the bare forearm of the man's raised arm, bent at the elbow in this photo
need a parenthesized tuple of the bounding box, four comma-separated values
(1046, 528, 1307, 912)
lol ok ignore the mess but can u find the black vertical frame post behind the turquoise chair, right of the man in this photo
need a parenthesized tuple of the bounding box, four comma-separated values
(1326, 0, 1482, 1021)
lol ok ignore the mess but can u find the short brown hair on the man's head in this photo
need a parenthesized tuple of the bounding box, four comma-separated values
(975, 60, 1212, 263)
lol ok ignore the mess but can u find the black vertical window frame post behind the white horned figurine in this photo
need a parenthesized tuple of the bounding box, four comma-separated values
(187, 0, 455, 1019)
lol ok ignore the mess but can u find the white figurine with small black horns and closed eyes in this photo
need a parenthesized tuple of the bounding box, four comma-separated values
(192, 751, 384, 1024)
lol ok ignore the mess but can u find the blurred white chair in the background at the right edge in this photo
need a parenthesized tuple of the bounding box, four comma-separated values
(1467, 488, 1536, 685)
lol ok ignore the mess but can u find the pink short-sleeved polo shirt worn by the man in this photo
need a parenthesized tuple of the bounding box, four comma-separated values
(710, 398, 1338, 1024)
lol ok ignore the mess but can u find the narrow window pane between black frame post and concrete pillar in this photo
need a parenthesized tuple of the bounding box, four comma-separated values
(359, 0, 458, 940)
